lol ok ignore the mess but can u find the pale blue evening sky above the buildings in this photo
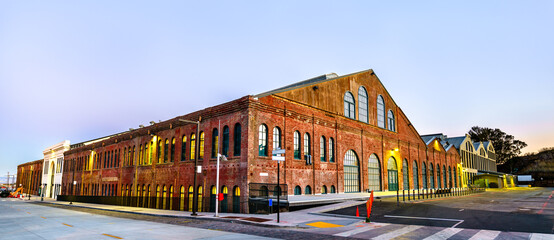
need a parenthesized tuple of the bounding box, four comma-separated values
(0, 0, 554, 176)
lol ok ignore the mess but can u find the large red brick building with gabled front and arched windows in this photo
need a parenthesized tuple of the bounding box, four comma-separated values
(62, 70, 460, 212)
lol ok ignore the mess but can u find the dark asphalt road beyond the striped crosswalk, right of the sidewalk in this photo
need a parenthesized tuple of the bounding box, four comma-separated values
(328, 188, 554, 233)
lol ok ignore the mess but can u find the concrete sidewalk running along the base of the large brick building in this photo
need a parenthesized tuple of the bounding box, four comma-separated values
(19, 194, 369, 228)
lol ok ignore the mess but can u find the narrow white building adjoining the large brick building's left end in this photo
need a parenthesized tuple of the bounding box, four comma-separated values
(41, 140, 69, 199)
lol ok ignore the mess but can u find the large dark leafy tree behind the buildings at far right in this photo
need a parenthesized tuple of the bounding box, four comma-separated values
(468, 126, 527, 164)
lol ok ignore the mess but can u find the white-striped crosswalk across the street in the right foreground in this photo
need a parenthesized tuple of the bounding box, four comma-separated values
(305, 223, 554, 240)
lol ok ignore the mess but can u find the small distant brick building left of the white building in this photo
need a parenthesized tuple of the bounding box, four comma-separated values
(16, 159, 43, 195)
